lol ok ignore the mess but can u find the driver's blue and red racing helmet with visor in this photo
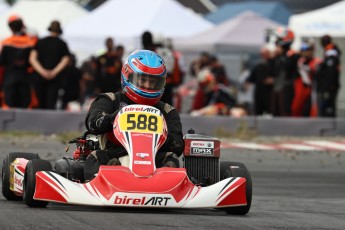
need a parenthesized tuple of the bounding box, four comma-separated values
(121, 50, 167, 105)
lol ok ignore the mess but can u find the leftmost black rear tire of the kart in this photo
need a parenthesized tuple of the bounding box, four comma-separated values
(1, 152, 39, 200)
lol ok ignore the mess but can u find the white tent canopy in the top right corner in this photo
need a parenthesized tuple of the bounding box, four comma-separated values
(289, 1, 345, 37)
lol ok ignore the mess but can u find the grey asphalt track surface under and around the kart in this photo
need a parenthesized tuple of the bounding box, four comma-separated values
(0, 137, 345, 230)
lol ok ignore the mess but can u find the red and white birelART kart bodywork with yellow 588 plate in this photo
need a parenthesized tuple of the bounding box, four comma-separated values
(4, 105, 247, 212)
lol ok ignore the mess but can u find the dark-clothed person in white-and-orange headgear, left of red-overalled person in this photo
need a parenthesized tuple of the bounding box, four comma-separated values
(272, 27, 299, 116)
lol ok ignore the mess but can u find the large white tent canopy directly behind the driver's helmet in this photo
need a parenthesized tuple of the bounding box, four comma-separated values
(65, 0, 213, 59)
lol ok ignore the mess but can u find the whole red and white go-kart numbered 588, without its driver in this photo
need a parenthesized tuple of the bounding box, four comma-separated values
(2, 105, 252, 215)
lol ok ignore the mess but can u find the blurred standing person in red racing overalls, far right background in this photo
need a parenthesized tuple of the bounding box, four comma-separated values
(291, 40, 320, 117)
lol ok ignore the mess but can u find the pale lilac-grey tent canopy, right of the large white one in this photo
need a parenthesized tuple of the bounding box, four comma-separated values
(175, 11, 280, 51)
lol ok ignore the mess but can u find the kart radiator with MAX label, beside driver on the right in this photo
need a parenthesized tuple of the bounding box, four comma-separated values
(183, 134, 220, 185)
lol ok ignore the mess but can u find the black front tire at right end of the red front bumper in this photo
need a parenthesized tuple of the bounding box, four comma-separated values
(220, 161, 253, 215)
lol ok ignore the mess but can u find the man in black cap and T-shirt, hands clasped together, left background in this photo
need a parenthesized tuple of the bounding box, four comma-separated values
(30, 21, 70, 109)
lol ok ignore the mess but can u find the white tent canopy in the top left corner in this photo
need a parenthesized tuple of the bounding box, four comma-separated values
(0, 0, 88, 39)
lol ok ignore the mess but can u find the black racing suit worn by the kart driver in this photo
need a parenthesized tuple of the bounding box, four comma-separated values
(84, 93, 184, 179)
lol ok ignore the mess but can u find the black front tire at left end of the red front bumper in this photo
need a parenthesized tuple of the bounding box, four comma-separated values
(23, 159, 52, 208)
